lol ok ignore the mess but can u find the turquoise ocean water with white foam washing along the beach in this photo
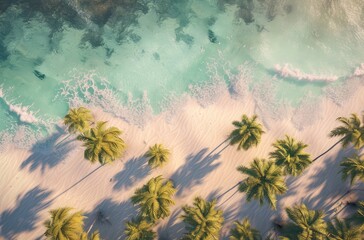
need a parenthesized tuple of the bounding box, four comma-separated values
(0, 0, 364, 145)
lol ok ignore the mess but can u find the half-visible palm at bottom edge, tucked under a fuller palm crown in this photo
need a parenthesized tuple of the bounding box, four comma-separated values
(124, 219, 156, 240)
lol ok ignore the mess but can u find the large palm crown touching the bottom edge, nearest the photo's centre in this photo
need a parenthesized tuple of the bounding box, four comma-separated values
(181, 197, 224, 240)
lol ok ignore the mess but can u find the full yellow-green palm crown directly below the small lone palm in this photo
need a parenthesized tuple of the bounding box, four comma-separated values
(131, 176, 176, 222)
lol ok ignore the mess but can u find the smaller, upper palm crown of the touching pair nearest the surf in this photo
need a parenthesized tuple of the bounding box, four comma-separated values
(63, 107, 94, 133)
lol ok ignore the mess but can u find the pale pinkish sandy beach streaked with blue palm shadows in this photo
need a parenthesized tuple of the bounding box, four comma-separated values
(0, 80, 364, 239)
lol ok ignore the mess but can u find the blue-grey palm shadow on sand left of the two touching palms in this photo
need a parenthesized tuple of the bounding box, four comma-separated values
(20, 127, 73, 173)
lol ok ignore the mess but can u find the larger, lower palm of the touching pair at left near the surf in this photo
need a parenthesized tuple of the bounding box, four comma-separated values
(77, 122, 125, 164)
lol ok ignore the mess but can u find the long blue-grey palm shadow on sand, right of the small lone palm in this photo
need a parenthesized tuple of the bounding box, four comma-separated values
(171, 148, 220, 196)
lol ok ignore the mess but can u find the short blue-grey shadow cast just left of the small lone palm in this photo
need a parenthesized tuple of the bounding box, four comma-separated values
(113, 156, 151, 190)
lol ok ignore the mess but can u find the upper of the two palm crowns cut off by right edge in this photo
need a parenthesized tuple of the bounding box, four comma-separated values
(329, 113, 364, 148)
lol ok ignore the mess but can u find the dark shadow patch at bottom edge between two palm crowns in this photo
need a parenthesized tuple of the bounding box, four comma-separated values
(157, 208, 185, 240)
